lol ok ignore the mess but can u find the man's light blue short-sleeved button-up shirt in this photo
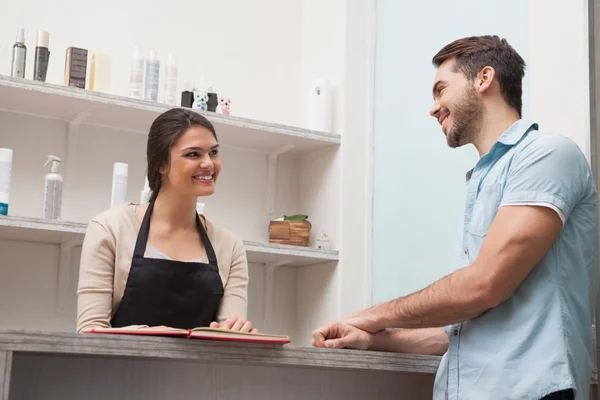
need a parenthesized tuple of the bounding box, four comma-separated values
(434, 120, 598, 400)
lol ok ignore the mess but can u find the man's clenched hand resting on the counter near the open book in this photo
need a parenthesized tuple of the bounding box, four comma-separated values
(312, 322, 373, 350)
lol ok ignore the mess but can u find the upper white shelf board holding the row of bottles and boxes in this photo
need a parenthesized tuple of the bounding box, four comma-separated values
(0, 75, 341, 156)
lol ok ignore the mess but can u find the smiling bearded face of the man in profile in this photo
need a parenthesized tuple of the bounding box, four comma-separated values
(429, 59, 484, 148)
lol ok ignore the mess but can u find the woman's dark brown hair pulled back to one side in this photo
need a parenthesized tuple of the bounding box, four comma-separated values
(146, 108, 217, 201)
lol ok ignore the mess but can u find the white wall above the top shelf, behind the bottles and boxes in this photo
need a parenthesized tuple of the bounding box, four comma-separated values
(0, 0, 344, 130)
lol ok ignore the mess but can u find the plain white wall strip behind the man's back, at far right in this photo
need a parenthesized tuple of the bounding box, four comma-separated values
(529, 0, 590, 161)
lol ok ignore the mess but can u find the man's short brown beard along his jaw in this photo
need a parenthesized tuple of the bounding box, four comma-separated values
(446, 86, 484, 148)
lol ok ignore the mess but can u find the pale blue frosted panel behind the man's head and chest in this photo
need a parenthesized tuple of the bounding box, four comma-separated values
(373, 0, 531, 302)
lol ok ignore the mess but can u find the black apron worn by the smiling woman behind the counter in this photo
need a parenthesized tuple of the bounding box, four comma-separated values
(111, 202, 223, 329)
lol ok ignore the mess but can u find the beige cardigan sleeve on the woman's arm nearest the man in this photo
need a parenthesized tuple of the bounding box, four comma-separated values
(217, 239, 249, 324)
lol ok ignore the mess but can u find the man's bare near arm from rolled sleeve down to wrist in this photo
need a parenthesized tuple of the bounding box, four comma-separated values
(344, 206, 562, 332)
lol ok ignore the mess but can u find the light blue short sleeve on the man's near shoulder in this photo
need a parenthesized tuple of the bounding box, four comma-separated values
(501, 135, 591, 222)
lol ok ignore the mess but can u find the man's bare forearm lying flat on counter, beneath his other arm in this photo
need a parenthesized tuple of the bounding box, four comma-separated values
(369, 328, 448, 356)
